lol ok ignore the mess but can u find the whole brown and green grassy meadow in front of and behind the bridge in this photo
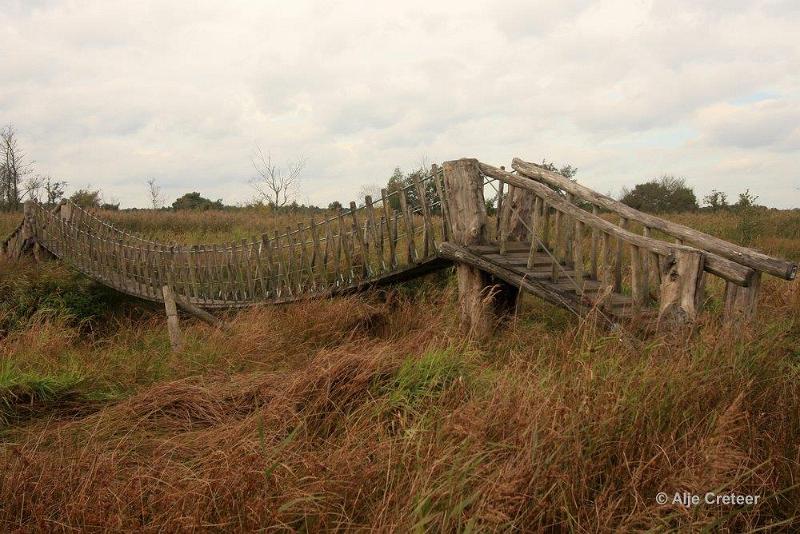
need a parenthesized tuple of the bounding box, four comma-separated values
(0, 210, 800, 532)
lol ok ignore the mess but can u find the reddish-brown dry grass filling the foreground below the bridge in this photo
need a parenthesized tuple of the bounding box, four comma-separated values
(0, 276, 800, 531)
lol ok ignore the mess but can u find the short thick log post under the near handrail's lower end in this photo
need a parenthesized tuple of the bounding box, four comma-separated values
(658, 250, 705, 324)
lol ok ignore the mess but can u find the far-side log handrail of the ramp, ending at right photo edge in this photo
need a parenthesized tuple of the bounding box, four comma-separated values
(512, 158, 797, 280)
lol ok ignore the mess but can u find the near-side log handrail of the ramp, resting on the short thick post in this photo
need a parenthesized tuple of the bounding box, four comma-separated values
(480, 163, 755, 286)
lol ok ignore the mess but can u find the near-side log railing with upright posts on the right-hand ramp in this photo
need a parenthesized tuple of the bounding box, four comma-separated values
(480, 160, 754, 322)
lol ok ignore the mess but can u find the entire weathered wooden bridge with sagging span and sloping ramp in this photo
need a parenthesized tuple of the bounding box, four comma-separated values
(2, 159, 797, 334)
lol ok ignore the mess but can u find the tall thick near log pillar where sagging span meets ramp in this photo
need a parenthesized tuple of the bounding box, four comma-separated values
(443, 159, 518, 339)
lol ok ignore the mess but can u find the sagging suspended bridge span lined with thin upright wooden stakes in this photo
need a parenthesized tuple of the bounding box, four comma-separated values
(21, 170, 448, 308)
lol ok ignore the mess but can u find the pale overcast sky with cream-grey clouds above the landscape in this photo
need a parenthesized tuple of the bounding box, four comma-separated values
(0, 0, 800, 208)
